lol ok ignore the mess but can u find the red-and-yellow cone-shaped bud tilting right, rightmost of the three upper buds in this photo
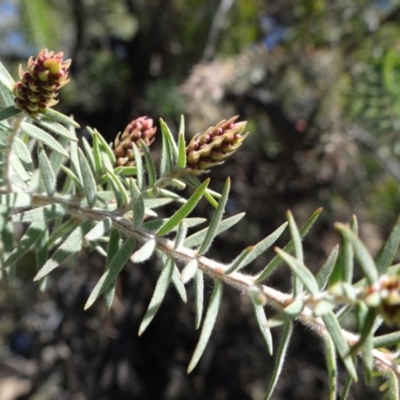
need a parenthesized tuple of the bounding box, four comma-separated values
(186, 116, 249, 174)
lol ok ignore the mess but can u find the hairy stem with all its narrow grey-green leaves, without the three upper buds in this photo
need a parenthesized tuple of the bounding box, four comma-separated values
(0, 57, 400, 399)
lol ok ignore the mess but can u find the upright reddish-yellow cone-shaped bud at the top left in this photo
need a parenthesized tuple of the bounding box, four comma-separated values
(14, 49, 71, 115)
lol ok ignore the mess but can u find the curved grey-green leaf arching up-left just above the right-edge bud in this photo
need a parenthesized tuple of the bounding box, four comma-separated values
(335, 223, 379, 285)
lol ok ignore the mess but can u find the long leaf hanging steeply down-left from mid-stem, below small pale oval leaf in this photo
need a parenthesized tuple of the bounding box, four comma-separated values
(138, 259, 174, 336)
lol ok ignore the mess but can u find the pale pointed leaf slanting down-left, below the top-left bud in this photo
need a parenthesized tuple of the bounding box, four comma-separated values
(33, 221, 91, 281)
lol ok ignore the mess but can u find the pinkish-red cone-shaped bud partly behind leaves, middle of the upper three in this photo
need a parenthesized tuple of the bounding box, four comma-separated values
(114, 117, 157, 167)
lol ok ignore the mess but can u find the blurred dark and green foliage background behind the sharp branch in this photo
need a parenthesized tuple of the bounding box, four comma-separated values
(0, 0, 400, 400)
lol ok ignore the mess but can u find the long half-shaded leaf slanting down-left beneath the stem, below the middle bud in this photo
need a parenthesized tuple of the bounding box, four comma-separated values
(84, 238, 135, 310)
